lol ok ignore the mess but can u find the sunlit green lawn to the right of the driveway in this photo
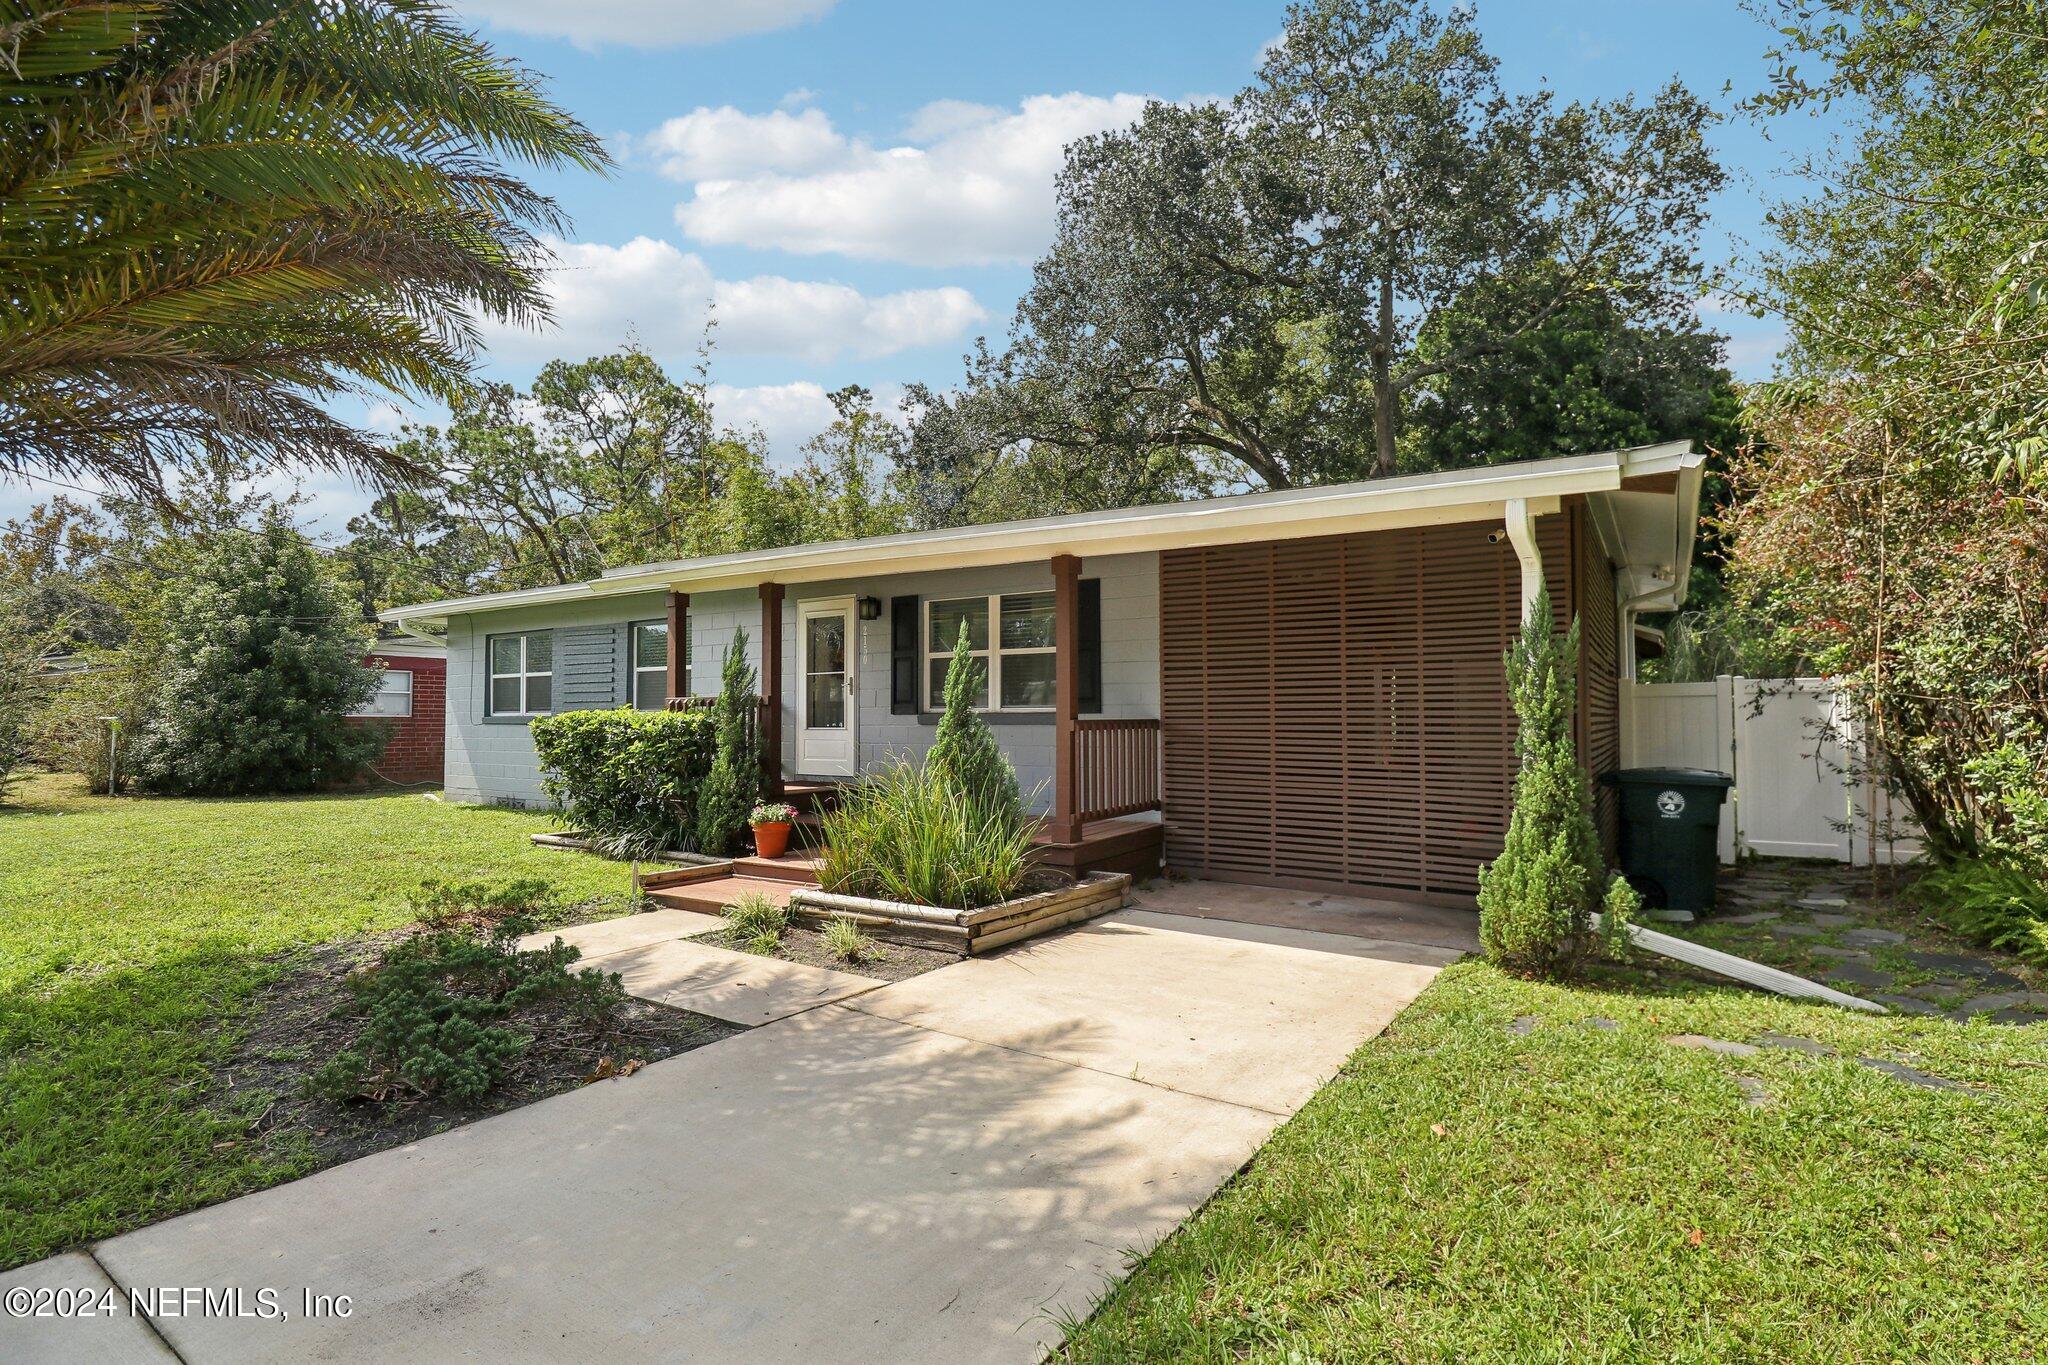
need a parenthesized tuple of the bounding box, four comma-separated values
(1067, 962, 2048, 1361)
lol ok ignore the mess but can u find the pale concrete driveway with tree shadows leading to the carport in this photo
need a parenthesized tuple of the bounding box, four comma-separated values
(0, 896, 1456, 1365)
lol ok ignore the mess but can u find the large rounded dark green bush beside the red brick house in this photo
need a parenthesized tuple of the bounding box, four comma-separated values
(133, 516, 383, 794)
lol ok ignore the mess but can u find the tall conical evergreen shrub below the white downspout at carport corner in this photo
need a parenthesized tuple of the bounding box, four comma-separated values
(1479, 593, 1640, 978)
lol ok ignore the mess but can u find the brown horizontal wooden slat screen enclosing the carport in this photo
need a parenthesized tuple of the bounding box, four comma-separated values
(1159, 516, 1577, 896)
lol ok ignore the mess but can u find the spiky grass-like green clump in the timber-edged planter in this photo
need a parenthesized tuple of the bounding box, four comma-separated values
(817, 759, 1038, 911)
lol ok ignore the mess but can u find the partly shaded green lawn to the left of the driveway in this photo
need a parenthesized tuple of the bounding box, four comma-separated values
(0, 776, 629, 1269)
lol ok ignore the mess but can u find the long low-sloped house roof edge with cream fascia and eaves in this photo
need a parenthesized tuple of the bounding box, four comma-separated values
(381, 440, 1706, 626)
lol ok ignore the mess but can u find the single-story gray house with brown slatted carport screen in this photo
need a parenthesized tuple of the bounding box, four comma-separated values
(385, 442, 1704, 902)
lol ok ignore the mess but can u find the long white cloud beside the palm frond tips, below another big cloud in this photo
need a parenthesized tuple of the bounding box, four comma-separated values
(487, 237, 987, 362)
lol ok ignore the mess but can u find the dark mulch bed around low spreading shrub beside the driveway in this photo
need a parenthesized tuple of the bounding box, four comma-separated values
(207, 929, 745, 1169)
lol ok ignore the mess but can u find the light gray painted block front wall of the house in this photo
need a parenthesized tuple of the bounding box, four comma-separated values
(446, 555, 1159, 808)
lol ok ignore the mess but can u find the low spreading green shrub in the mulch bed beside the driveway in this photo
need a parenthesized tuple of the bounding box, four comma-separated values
(309, 886, 627, 1103)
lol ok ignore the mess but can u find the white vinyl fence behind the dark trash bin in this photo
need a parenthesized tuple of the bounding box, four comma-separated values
(1622, 675, 1919, 866)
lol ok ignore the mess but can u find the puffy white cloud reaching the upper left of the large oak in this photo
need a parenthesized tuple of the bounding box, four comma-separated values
(655, 94, 1145, 266)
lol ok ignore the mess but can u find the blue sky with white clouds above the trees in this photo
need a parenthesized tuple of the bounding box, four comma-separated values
(0, 0, 1810, 530)
